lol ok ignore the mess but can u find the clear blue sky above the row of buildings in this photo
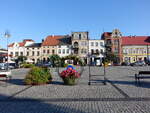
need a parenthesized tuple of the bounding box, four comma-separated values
(0, 0, 150, 47)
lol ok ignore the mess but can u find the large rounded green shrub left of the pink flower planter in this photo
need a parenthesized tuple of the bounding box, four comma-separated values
(24, 67, 52, 85)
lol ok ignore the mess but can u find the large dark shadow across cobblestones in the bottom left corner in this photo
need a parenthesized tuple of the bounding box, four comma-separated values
(0, 94, 85, 113)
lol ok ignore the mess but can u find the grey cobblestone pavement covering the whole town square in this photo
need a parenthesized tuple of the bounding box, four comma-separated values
(0, 66, 150, 113)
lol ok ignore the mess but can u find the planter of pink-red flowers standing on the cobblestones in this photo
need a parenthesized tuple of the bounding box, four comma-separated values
(60, 68, 80, 85)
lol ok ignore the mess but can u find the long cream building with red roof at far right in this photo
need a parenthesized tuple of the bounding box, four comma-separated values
(122, 36, 150, 63)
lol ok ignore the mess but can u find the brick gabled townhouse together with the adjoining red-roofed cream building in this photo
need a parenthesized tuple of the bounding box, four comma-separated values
(101, 29, 150, 63)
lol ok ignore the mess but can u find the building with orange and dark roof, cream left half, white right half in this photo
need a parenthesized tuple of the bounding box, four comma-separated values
(41, 35, 72, 62)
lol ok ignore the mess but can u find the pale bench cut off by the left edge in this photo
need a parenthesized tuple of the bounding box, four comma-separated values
(0, 71, 11, 83)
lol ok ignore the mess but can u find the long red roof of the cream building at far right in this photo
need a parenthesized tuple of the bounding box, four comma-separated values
(122, 36, 150, 45)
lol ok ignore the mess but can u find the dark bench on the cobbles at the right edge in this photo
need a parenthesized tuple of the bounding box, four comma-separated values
(135, 71, 150, 84)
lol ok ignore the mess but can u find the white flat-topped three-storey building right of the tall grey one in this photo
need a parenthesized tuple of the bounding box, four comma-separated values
(89, 39, 105, 65)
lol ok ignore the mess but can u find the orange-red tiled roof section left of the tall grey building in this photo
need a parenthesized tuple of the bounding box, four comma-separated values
(42, 36, 64, 46)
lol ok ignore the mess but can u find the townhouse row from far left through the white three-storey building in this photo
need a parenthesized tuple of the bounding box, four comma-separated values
(8, 32, 104, 65)
